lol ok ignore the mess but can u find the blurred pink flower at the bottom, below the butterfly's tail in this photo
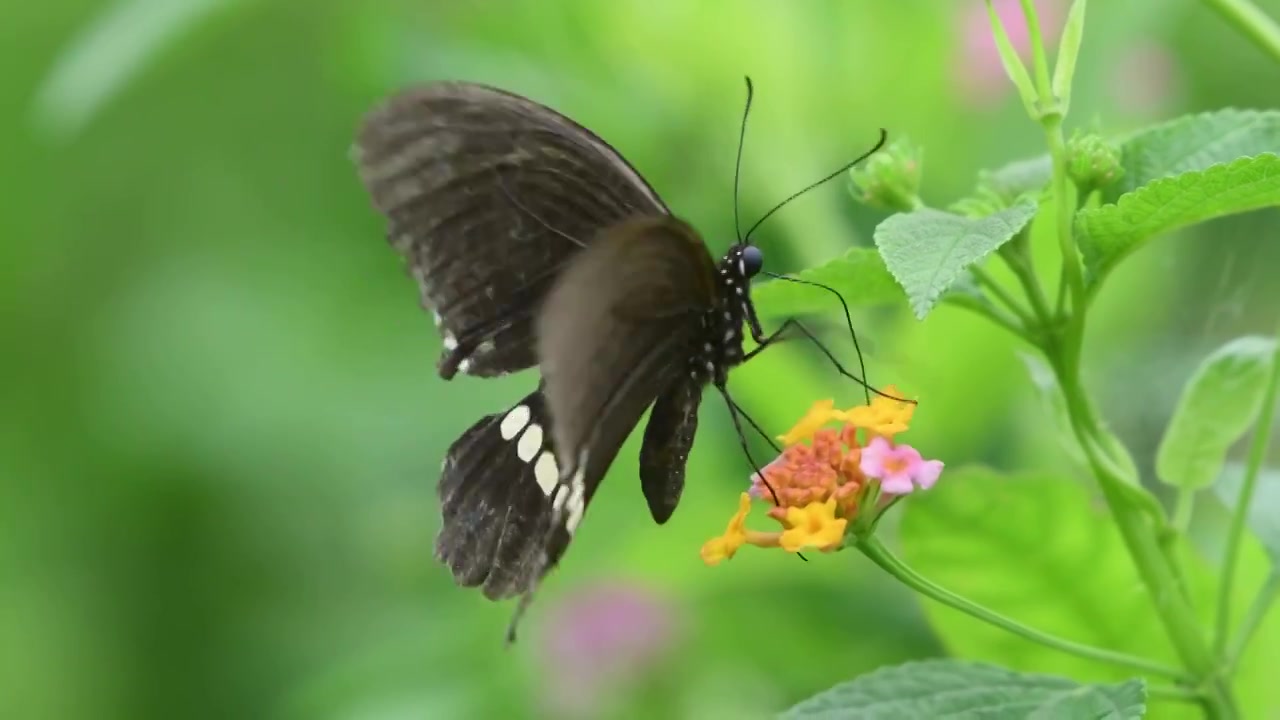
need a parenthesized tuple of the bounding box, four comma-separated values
(540, 584, 677, 719)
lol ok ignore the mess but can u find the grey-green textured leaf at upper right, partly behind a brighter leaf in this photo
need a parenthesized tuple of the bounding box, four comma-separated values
(1107, 108, 1280, 196)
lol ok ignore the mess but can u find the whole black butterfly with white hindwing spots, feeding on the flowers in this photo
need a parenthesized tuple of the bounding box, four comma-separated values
(356, 81, 883, 627)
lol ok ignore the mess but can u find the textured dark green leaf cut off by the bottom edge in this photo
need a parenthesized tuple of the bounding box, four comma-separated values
(780, 660, 1147, 720)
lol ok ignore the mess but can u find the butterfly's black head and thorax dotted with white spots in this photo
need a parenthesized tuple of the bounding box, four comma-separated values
(689, 245, 760, 387)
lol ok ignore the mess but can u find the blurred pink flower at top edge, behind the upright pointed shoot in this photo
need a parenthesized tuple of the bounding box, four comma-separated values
(952, 0, 1066, 108)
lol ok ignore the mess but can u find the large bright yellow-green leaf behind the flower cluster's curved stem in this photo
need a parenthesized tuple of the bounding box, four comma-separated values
(900, 468, 1178, 680)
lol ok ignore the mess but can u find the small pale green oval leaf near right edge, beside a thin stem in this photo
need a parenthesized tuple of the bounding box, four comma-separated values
(1156, 337, 1276, 489)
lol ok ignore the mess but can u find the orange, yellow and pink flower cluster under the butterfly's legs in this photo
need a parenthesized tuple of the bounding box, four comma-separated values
(701, 386, 942, 565)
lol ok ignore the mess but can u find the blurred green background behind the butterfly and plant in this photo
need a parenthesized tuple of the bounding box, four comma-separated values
(0, 0, 1280, 719)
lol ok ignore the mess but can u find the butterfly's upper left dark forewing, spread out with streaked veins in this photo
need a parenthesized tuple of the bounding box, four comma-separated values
(356, 83, 667, 378)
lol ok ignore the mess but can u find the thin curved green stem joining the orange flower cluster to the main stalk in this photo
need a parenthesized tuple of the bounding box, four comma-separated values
(855, 536, 1187, 680)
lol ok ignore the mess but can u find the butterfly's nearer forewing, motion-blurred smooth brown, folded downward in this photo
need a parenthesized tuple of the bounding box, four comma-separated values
(538, 217, 716, 540)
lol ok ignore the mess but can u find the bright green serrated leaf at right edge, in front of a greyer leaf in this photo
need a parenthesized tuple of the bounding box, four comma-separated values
(1075, 154, 1280, 278)
